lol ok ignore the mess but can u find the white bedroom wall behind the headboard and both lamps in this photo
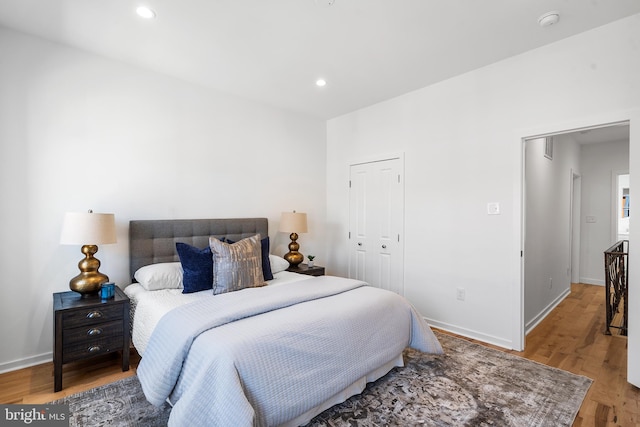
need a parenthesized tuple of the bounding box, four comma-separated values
(0, 28, 326, 371)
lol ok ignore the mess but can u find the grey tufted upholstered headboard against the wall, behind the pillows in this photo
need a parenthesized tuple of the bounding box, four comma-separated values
(129, 218, 269, 278)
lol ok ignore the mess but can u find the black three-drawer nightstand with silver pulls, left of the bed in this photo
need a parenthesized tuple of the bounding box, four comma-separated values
(53, 286, 130, 392)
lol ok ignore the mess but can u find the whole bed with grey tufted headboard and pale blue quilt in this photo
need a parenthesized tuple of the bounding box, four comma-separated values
(125, 218, 442, 427)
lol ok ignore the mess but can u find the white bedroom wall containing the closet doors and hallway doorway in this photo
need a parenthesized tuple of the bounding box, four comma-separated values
(327, 10, 640, 368)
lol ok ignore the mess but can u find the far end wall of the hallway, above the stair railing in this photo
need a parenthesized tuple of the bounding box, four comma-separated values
(580, 141, 629, 285)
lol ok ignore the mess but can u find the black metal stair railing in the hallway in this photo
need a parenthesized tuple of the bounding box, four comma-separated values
(604, 240, 629, 335)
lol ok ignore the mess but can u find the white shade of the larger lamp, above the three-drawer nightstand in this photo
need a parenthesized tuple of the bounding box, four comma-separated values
(60, 212, 116, 245)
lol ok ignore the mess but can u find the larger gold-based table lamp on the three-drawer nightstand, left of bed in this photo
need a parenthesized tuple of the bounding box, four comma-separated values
(60, 211, 116, 297)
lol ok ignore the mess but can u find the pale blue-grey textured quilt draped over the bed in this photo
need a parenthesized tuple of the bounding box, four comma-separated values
(136, 276, 442, 427)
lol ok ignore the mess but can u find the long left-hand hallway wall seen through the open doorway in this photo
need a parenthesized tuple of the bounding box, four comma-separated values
(524, 135, 584, 331)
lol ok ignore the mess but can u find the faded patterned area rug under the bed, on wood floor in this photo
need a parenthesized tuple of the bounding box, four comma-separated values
(53, 334, 591, 427)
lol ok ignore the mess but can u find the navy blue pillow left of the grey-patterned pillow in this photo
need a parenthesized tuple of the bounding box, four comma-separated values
(176, 243, 213, 294)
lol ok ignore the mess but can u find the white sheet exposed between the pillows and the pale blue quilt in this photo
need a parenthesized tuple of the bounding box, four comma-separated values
(124, 271, 312, 356)
